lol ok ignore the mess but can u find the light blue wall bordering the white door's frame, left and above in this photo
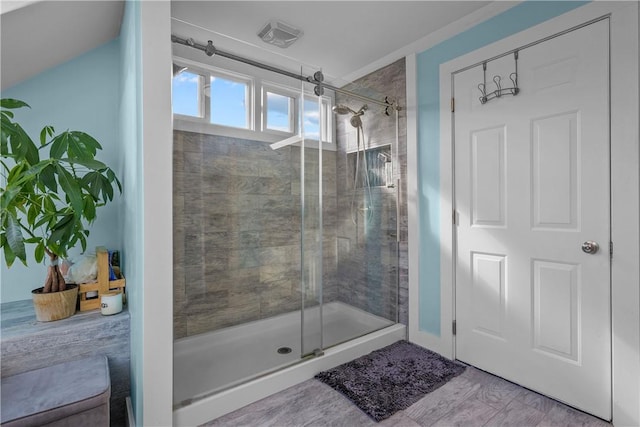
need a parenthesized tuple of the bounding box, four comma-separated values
(417, 1, 586, 336)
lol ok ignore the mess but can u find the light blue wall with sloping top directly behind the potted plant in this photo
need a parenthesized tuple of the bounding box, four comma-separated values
(0, 40, 123, 302)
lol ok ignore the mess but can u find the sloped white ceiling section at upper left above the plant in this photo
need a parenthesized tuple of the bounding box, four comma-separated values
(0, 0, 124, 89)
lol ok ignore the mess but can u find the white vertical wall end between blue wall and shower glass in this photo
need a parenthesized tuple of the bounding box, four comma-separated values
(140, 1, 173, 426)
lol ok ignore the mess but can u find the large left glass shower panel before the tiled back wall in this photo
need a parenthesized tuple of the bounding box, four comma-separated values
(173, 46, 322, 407)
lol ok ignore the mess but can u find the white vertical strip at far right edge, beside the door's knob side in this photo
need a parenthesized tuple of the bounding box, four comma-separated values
(611, 2, 640, 426)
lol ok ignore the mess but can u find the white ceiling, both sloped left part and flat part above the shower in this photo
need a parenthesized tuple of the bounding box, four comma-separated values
(0, 0, 498, 89)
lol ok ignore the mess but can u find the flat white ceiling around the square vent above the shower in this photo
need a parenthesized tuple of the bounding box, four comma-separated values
(171, 0, 491, 80)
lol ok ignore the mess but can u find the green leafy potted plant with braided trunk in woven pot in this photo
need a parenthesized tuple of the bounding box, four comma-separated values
(0, 99, 122, 321)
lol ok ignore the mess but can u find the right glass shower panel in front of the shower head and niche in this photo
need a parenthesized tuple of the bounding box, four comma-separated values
(323, 75, 400, 348)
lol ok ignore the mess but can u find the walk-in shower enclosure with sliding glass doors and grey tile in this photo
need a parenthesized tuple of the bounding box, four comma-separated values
(173, 18, 400, 418)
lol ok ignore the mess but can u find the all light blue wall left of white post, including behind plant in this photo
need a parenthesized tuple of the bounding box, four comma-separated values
(0, 0, 144, 425)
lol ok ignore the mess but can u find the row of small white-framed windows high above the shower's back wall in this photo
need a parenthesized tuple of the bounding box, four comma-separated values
(172, 58, 335, 150)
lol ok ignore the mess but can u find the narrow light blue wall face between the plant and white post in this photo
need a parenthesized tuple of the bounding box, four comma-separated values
(118, 1, 144, 426)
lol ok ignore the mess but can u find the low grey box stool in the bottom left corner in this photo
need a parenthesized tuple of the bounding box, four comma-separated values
(0, 356, 111, 427)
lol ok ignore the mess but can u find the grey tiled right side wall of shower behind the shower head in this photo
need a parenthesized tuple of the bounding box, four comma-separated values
(336, 58, 408, 324)
